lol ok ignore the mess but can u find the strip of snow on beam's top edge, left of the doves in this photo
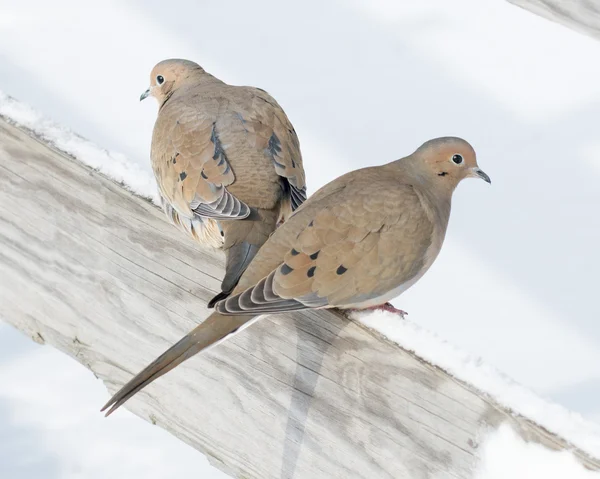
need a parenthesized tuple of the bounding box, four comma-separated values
(0, 91, 158, 204)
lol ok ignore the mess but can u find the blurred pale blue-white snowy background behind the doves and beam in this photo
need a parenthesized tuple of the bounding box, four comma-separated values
(0, 0, 600, 479)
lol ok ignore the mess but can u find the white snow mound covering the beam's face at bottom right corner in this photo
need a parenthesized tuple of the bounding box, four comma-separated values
(473, 424, 600, 479)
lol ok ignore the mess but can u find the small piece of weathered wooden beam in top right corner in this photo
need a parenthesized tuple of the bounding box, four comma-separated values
(508, 0, 600, 40)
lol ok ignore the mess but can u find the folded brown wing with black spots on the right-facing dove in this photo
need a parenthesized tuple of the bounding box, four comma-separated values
(216, 176, 434, 314)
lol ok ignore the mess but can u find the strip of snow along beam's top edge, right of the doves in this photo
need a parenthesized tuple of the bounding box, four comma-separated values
(352, 311, 600, 457)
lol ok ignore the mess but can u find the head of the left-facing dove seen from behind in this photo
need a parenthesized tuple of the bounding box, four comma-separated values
(140, 58, 204, 105)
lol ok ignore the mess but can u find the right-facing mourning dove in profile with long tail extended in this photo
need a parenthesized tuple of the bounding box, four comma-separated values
(103, 137, 490, 415)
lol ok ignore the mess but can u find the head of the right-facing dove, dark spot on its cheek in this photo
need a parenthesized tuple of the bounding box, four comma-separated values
(413, 136, 491, 190)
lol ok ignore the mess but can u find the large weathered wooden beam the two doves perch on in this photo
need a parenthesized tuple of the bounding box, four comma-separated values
(0, 120, 600, 479)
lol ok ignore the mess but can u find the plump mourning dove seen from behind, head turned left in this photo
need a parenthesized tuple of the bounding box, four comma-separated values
(140, 59, 306, 307)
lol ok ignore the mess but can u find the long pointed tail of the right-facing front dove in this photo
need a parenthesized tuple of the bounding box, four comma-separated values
(102, 313, 255, 416)
